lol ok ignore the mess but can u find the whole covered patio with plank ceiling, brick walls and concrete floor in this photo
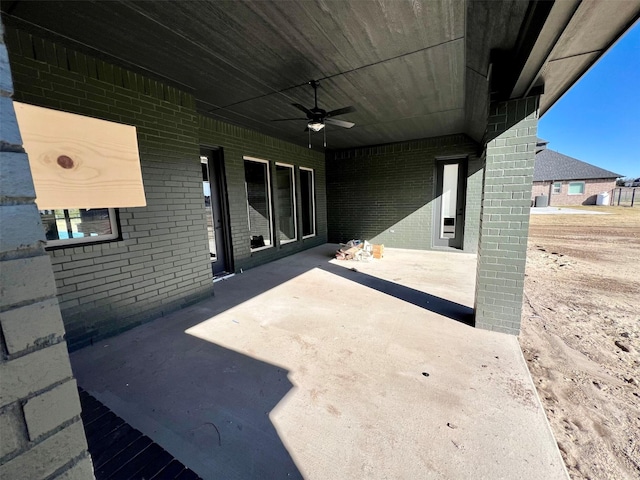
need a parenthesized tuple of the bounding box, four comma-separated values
(0, 0, 640, 480)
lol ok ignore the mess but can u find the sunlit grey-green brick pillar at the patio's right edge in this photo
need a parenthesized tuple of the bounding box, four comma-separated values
(475, 96, 539, 335)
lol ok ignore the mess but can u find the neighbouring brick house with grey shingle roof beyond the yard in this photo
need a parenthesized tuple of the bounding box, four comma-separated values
(531, 139, 622, 205)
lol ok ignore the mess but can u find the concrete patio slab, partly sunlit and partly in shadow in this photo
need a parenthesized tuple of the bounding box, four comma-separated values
(72, 245, 568, 479)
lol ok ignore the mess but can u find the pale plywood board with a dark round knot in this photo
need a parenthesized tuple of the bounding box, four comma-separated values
(14, 102, 146, 210)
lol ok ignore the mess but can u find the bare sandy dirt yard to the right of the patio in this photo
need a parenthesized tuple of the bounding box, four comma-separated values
(520, 207, 640, 480)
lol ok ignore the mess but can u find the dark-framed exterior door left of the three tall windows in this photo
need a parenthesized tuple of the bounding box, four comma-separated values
(200, 149, 231, 277)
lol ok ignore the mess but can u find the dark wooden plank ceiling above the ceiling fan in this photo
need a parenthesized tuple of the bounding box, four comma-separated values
(2, 0, 636, 148)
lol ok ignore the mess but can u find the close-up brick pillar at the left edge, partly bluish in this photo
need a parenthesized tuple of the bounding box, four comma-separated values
(0, 17, 94, 480)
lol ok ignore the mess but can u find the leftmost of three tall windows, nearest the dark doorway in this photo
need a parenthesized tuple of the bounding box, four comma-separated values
(244, 157, 273, 252)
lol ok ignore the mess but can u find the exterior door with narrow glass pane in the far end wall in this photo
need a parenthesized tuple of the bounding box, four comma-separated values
(433, 158, 467, 250)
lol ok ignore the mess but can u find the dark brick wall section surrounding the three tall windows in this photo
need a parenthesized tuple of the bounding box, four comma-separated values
(199, 115, 327, 271)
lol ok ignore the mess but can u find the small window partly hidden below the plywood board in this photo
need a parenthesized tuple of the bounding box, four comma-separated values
(40, 208, 119, 247)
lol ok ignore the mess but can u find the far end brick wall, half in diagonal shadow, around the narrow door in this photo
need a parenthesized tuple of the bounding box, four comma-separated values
(327, 135, 482, 252)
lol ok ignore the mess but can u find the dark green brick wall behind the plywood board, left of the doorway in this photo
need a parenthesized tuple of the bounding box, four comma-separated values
(7, 29, 212, 349)
